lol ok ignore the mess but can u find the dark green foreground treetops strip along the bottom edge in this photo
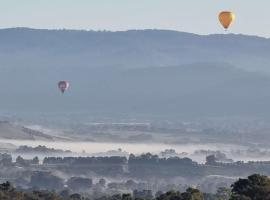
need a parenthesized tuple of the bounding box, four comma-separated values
(0, 174, 270, 200)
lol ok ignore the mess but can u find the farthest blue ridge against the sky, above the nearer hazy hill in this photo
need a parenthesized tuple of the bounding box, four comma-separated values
(0, 28, 270, 72)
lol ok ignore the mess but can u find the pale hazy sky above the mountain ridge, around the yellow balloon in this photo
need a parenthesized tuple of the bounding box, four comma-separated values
(0, 0, 270, 37)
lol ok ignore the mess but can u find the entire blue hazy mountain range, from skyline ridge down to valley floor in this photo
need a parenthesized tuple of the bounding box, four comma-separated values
(0, 28, 270, 117)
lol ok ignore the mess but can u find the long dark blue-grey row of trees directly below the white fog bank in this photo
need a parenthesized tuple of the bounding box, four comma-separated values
(0, 153, 270, 178)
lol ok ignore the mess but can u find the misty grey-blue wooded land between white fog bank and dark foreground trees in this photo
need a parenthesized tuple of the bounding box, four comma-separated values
(3, 153, 270, 194)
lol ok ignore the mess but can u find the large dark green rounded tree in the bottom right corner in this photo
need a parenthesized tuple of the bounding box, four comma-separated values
(231, 174, 270, 200)
